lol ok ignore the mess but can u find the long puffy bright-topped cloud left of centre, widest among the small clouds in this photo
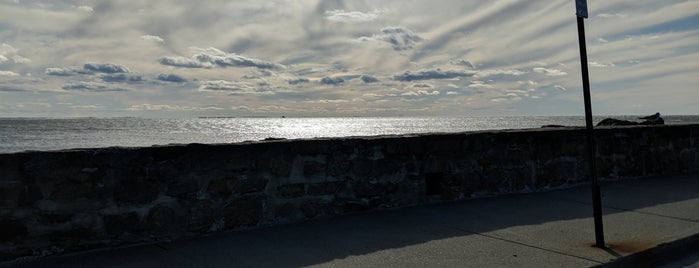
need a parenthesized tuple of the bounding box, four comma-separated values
(159, 47, 285, 69)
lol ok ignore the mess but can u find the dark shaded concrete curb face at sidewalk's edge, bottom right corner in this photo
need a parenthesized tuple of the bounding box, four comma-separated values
(595, 233, 699, 267)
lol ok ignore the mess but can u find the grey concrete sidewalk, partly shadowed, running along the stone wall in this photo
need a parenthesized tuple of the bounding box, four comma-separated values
(2, 174, 699, 267)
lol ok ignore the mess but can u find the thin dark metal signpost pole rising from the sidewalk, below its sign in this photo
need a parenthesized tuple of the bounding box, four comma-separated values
(578, 16, 606, 248)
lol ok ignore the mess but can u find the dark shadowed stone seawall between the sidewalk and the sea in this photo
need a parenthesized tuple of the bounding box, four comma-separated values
(0, 125, 699, 262)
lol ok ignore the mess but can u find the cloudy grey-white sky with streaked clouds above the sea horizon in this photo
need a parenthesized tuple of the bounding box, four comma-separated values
(0, 0, 699, 117)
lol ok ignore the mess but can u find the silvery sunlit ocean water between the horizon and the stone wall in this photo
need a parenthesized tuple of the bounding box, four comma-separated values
(0, 116, 699, 153)
